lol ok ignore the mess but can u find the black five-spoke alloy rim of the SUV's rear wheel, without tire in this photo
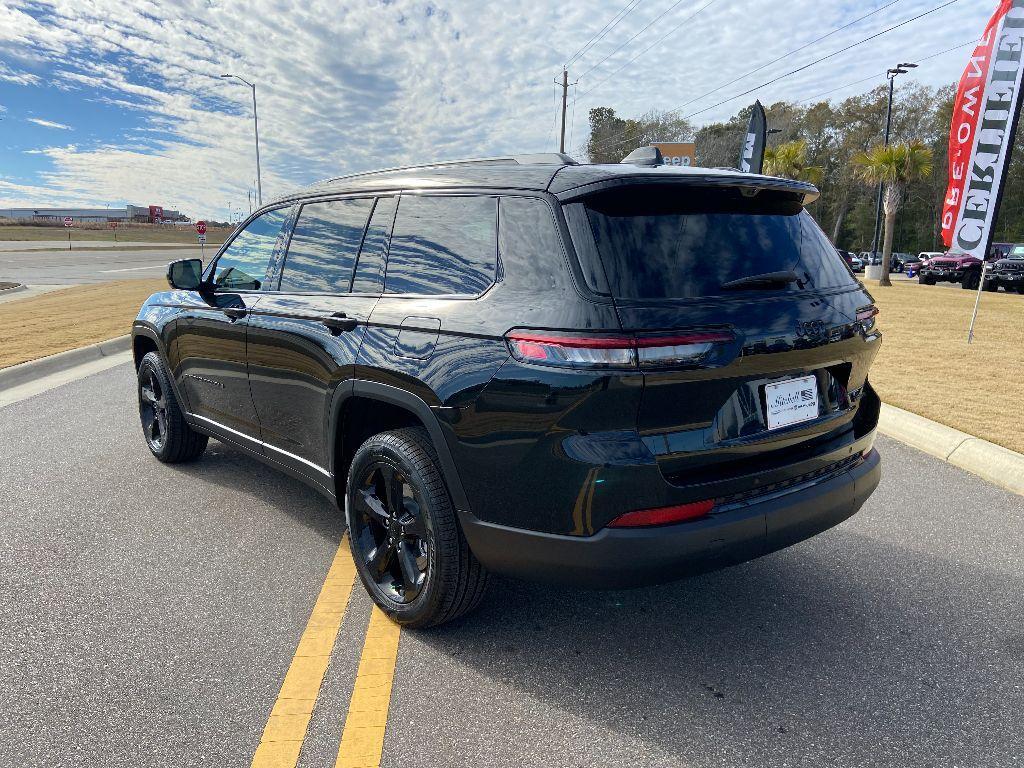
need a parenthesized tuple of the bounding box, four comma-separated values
(350, 461, 431, 604)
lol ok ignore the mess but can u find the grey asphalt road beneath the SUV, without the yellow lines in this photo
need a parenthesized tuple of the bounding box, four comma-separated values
(0, 365, 1024, 768)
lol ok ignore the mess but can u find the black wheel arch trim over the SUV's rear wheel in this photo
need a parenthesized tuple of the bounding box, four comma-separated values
(328, 380, 469, 511)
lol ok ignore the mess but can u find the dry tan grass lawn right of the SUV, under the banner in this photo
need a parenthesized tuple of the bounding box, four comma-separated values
(865, 282, 1024, 453)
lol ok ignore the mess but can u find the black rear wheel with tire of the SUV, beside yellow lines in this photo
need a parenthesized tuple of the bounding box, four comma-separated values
(345, 427, 487, 629)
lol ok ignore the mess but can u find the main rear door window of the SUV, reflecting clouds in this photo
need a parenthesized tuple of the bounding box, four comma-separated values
(281, 200, 373, 293)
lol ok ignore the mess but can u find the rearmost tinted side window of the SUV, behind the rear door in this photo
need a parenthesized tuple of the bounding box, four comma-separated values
(384, 196, 498, 296)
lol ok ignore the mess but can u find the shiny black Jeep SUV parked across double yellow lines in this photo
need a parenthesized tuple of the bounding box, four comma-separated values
(133, 156, 881, 627)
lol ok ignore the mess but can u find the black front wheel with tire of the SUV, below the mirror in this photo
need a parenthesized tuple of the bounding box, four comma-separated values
(138, 352, 209, 464)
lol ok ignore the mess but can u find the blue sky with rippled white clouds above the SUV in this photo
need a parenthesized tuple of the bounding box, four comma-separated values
(0, 0, 997, 218)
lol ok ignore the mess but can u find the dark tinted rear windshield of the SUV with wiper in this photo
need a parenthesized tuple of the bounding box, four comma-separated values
(585, 185, 856, 299)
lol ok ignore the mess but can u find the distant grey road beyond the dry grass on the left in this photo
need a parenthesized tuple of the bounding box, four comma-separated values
(0, 246, 205, 286)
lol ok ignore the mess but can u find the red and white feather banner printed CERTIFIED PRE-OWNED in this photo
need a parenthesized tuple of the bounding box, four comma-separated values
(942, 0, 1024, 258)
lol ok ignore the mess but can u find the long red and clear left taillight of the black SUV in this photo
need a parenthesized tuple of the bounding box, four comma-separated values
(505, 331, 734, 368)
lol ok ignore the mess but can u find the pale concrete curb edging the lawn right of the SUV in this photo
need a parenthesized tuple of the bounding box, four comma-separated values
(879, 403, 1024, 496)
